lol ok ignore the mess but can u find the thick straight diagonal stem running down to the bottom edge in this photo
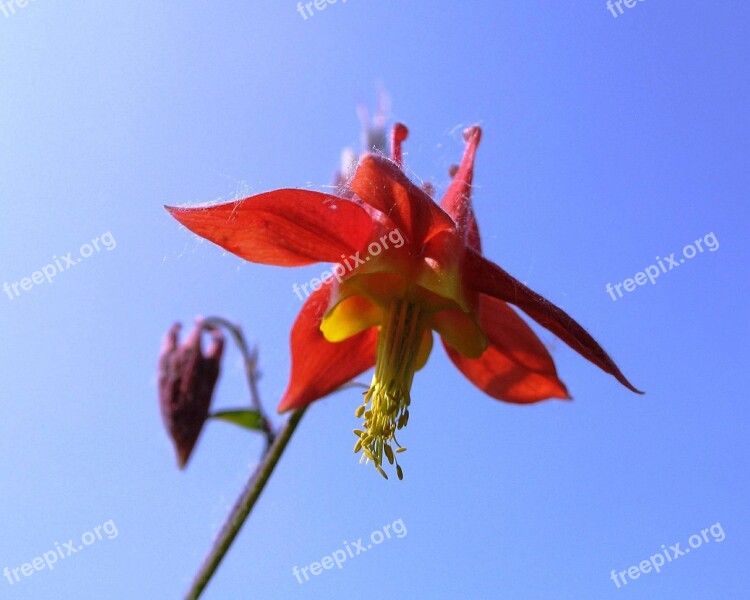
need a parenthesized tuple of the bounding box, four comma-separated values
(185, 408, 305, 600)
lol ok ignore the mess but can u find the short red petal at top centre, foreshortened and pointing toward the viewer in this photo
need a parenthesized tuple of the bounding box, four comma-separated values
(350, 154, 455, 250)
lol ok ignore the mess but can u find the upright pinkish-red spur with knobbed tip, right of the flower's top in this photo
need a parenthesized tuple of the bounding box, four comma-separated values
(440, 127, 482, 254)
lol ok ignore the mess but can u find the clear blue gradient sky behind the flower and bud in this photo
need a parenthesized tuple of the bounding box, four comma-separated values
(0, 0, 750, 600)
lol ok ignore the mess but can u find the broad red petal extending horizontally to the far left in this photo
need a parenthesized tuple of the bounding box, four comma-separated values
(166, 189, 373, 267)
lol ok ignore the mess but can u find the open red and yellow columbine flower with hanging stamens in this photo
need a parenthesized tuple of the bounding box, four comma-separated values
(168, 125, 638, 478)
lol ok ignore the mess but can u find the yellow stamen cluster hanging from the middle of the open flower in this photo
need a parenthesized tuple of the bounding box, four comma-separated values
(354, 299, 432, 479)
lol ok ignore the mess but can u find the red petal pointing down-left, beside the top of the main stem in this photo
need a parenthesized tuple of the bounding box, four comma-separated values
(277, 280, 378, 412)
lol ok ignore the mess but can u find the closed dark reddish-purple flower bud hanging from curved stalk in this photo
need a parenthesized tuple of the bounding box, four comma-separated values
(158, 319, 224, 469)
